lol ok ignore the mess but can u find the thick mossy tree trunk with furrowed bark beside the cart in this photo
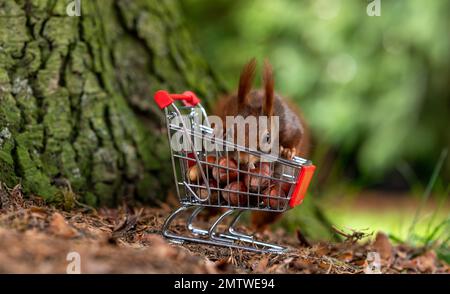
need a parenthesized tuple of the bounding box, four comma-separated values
(0, 0, 224, 205)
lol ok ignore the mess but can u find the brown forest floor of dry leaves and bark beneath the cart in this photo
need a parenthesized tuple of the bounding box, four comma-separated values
(0, 186, 450, 274)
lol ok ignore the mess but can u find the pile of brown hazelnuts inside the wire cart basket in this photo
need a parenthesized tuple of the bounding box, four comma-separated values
(186, 155, 291, 209)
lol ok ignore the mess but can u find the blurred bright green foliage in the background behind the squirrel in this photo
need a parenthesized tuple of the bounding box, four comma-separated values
(182, 0, 450, 190)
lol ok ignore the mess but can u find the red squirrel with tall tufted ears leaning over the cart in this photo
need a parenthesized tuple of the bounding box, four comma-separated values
(213, 58, 310, 230)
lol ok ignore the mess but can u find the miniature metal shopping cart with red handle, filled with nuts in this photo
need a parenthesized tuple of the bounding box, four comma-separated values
(154, 90, 315, 253)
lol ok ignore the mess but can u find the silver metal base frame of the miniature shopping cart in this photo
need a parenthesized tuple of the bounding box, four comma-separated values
(162, 205, 288, 254)
